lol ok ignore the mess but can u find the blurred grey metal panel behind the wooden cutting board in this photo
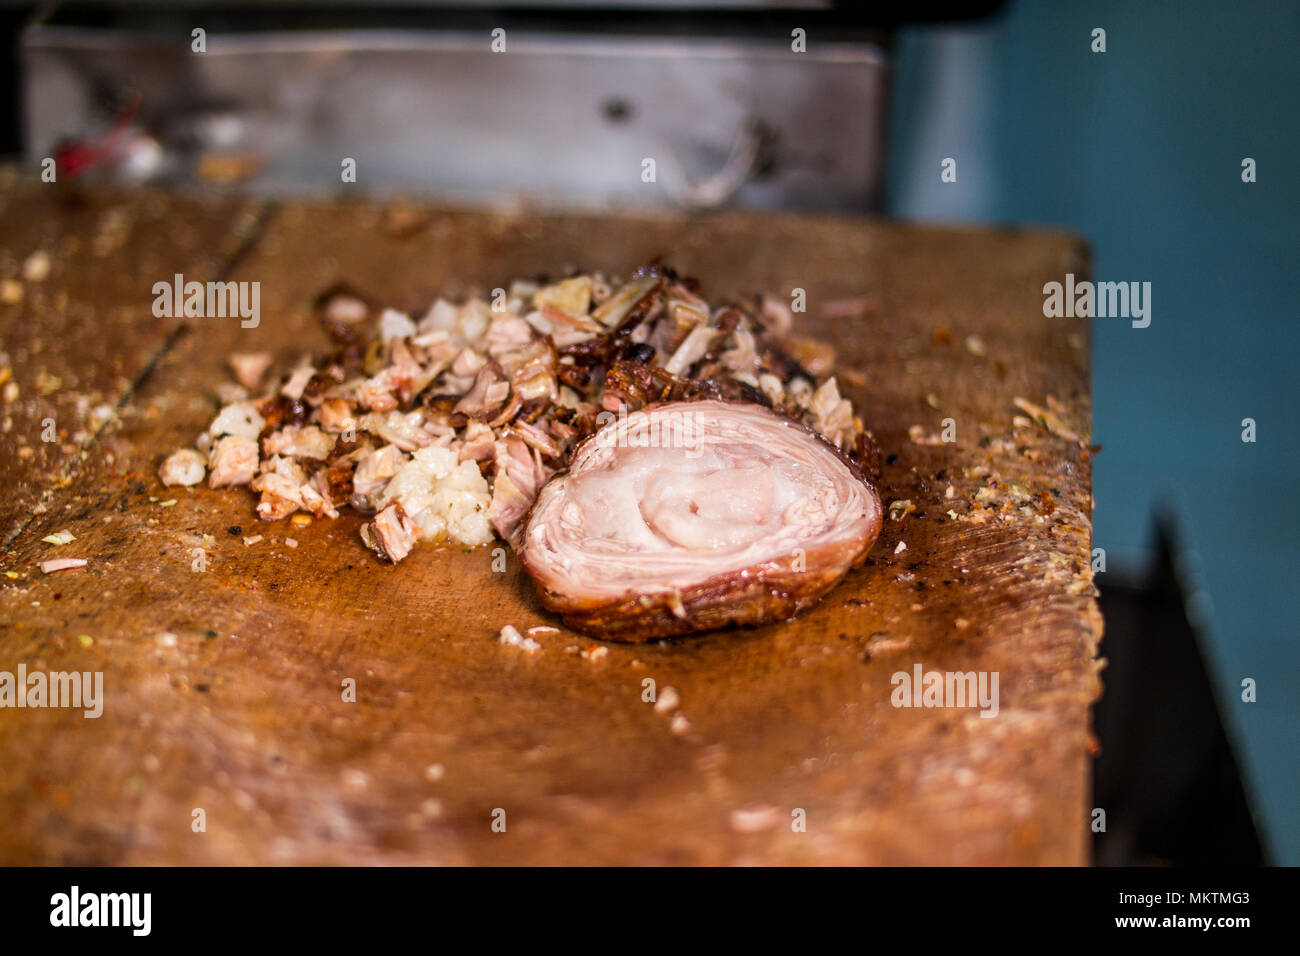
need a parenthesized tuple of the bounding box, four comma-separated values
(22, 23, 888, 212)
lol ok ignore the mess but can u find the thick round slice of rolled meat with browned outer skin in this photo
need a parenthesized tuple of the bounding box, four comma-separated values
(520, 401, 881, 641)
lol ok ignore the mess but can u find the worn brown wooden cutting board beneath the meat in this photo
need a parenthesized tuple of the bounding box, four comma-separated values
(0, 185, 1101, 864)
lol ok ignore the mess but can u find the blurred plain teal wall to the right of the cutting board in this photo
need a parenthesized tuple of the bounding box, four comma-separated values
(887, 0, 1300, 865)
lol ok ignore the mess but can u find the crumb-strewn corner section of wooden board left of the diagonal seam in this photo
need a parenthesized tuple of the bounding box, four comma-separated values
(0, 174, 265, 544)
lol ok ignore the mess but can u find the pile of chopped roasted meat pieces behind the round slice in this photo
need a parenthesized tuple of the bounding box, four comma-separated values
(159, 265, 875, 562)
